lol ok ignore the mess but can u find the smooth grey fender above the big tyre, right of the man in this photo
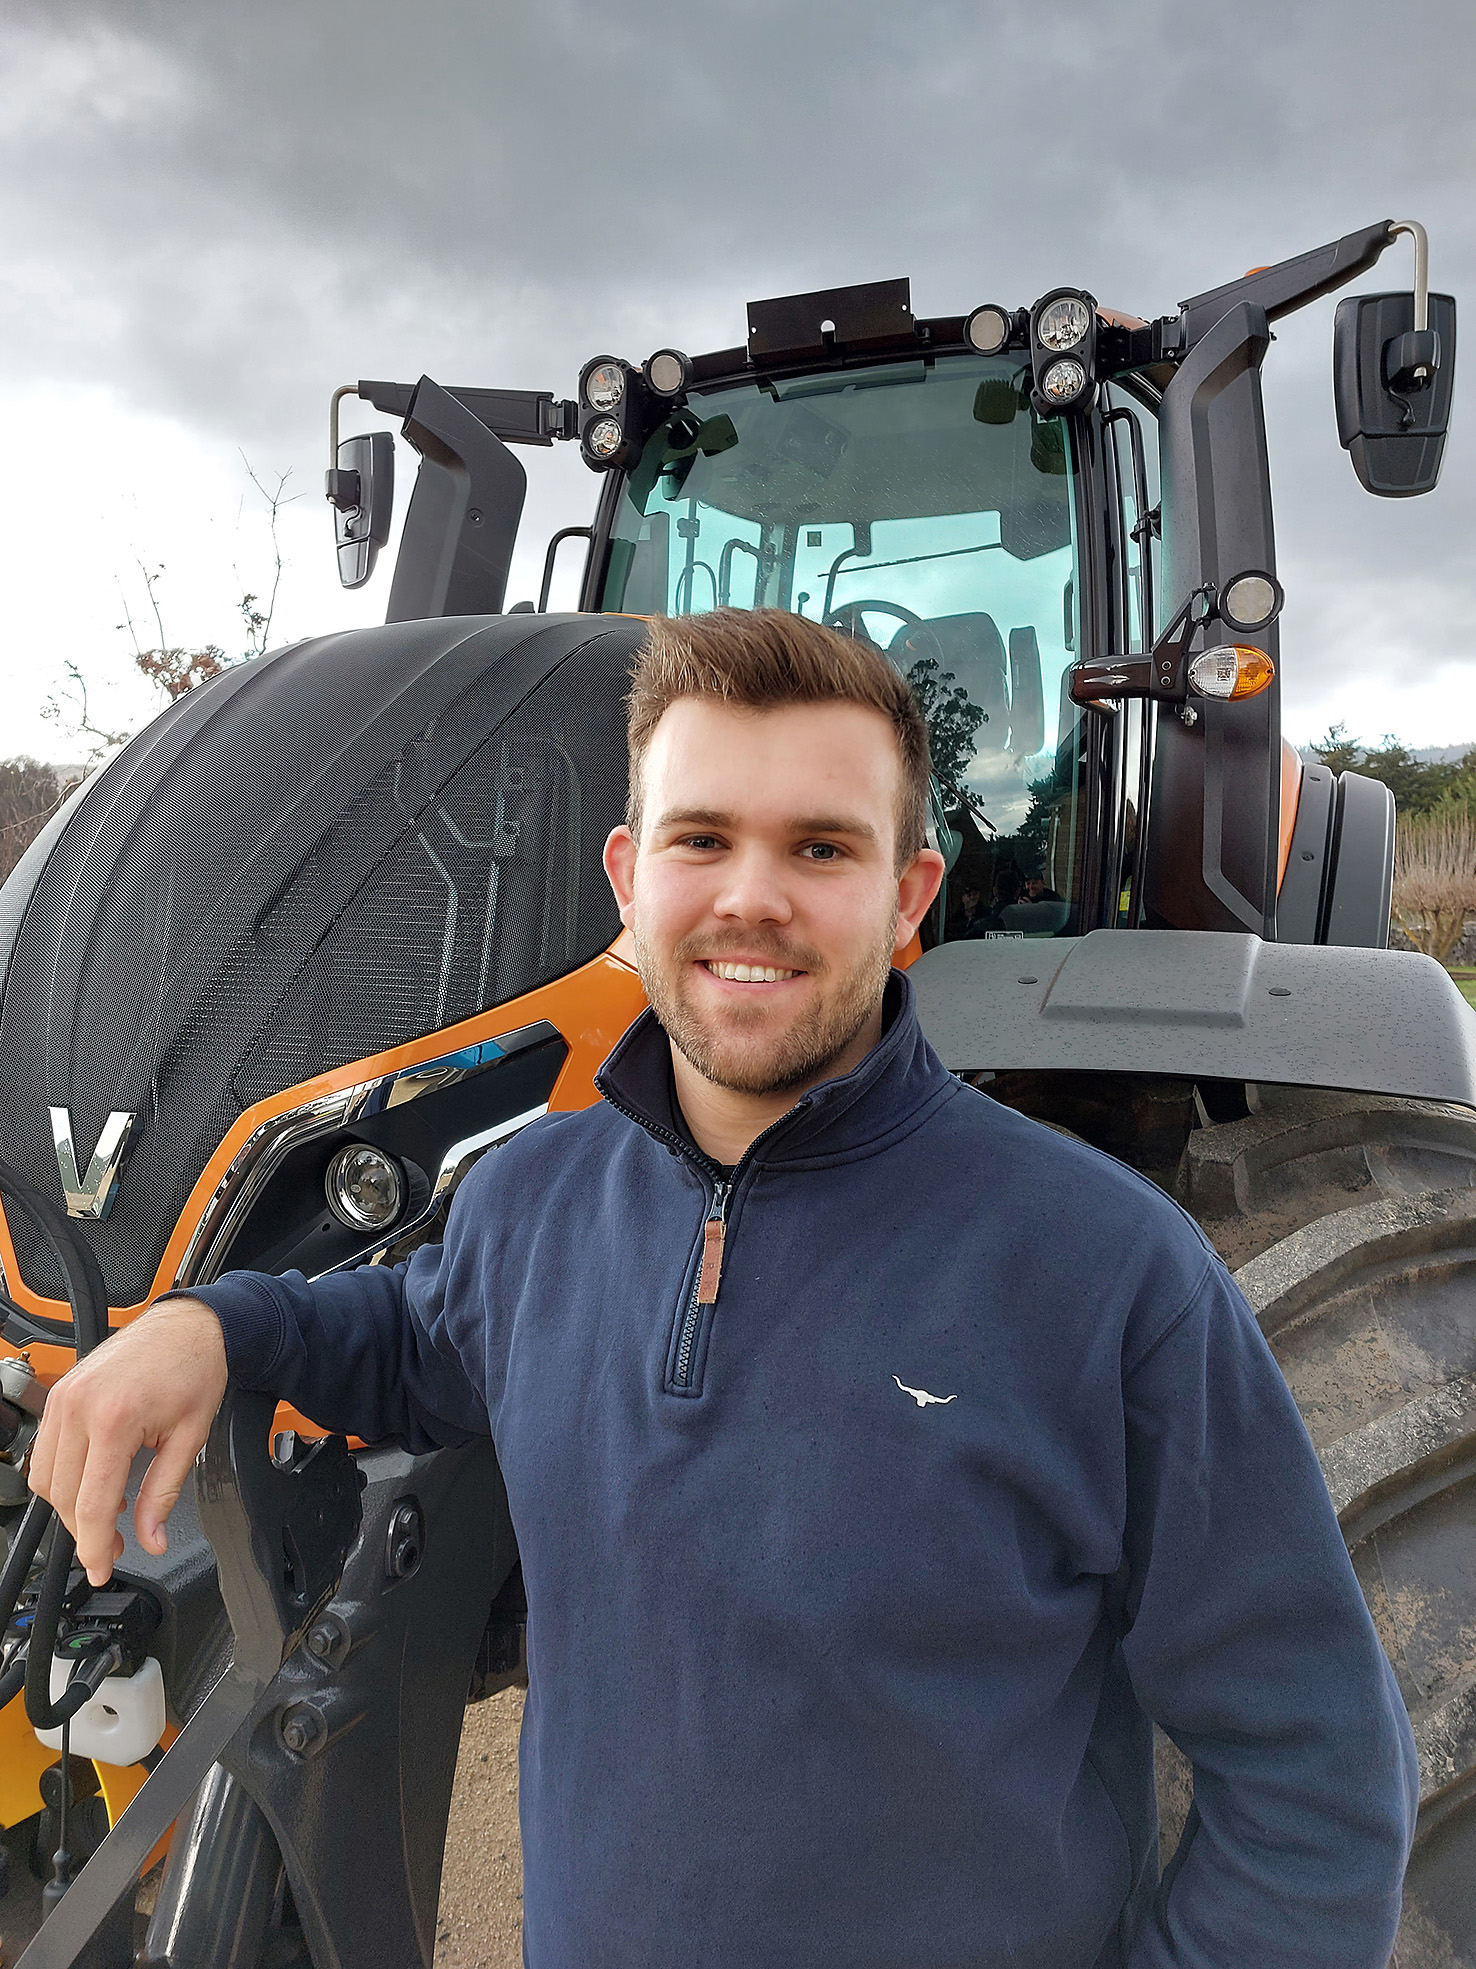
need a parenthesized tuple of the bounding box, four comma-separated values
(909, 929, 1476, 1109)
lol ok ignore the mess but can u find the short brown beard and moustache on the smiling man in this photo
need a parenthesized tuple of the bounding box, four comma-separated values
(634, 906, 897, 1095)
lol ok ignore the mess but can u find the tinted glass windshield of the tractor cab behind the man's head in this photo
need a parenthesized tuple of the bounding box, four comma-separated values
(600, 356, 1080, 935)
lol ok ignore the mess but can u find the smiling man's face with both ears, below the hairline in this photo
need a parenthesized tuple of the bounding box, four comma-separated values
(606, 699, 943, 1095)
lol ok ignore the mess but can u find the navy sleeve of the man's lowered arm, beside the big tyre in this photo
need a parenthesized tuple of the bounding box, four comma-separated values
(1124, 1262, 1419, 1969)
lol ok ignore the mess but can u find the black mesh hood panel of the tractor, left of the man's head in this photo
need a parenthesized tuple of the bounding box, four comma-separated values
(0, 616, 642, 1305)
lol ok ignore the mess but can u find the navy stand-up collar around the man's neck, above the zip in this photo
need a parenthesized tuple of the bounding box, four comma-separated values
(594, 971, 956, 1187)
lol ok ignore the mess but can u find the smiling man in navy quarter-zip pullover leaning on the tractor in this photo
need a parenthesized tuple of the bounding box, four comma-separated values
(31, 610, 1415, 1969)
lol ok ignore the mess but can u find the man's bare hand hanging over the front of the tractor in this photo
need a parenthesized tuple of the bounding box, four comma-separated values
(30, 1300, 226, 1587)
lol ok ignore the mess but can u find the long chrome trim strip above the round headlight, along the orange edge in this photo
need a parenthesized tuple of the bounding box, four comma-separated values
(173, 1018, 561, 1290)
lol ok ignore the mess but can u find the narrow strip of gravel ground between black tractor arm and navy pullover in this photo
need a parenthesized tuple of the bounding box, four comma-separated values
(435, 1689, 523, 1969)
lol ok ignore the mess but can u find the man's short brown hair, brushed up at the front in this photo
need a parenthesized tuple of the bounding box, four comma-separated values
(626, 608, 929, 868)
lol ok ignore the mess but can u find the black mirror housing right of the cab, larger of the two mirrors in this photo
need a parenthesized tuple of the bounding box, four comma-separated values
(1332, 293, 1456, 498)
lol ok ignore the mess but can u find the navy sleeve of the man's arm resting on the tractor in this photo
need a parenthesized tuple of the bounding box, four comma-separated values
(191, 1183, 490, 1455)
